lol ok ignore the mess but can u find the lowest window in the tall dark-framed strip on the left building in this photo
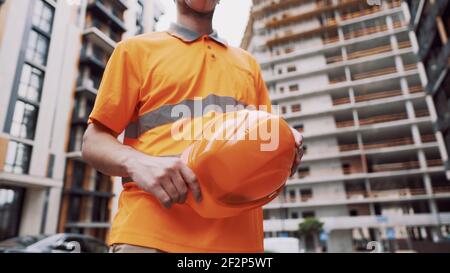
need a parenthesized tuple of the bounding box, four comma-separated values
(10, 100, 37, 139)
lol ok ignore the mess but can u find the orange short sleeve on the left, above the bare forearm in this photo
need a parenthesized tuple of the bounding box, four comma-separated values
(88, 43, 141, 134)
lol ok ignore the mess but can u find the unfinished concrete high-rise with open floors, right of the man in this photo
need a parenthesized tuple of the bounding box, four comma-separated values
(242, 0, 450, 252)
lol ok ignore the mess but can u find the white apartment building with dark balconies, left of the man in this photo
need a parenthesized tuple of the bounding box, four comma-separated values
(0, 0, 161, 240)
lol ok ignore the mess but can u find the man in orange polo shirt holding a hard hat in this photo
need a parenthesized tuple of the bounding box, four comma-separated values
(82, 0, 303, 252)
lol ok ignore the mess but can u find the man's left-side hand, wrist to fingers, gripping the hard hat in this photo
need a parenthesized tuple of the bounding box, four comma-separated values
(126, 154, 201, 208)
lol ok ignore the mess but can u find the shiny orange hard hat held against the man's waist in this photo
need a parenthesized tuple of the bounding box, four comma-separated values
(181, 110, 296, 218)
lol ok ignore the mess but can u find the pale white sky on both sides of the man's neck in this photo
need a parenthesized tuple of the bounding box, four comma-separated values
(156, 0, 252, 47)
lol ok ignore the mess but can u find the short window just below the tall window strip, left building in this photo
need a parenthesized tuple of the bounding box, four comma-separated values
(3, 141, 31, 174)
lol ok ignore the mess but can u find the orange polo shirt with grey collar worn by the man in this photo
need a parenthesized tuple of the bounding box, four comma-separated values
(89, 24, 270, 252)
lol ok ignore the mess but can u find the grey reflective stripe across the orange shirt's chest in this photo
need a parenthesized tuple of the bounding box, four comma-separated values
(125, 94, 247, 138)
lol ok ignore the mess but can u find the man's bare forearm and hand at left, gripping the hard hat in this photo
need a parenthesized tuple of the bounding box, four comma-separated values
(82, 122, 201, 208)
